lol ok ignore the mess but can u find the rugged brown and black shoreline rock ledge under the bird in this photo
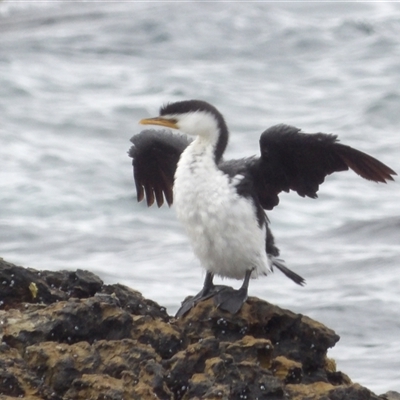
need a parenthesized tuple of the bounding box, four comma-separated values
(0, 259, 400, 400)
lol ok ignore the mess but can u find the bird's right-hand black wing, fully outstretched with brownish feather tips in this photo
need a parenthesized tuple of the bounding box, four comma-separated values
(251, 125, 396, 210)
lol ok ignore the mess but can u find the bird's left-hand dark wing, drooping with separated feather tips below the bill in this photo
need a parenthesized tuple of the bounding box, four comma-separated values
(128, 129, 190, 207)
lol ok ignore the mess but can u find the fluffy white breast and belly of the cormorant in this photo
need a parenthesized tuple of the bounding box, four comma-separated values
(174, 139, 270, 279)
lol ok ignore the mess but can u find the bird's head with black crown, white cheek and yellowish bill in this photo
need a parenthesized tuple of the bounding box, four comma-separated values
(140, 100, 228, 161)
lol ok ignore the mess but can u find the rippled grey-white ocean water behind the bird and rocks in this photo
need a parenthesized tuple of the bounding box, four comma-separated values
(0, 0, 400, 394)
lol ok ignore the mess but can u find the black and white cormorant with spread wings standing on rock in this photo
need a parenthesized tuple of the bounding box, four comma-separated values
(129, 100, 396, 317)
